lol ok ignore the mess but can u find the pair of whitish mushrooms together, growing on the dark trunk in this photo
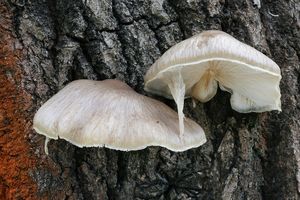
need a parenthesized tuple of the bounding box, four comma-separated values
(33, 31, 281, 153)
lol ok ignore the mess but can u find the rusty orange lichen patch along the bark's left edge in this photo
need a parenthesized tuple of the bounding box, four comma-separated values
(0, 2, 37, 200)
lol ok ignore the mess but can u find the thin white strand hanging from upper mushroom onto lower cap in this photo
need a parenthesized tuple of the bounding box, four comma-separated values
(168, 71, 185, 139)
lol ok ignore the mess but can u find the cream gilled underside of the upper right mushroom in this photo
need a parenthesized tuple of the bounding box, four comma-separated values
(151, 59, 281, 133)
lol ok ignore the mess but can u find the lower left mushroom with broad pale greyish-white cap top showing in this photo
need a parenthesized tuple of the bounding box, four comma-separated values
(33, 80, 206, 153)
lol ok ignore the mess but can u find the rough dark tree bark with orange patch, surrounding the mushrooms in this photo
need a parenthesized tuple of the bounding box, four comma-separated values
(0, 0, 300, 200)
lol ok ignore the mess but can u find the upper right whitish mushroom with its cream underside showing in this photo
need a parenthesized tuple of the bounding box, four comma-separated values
(144, 30, 281, 137)
